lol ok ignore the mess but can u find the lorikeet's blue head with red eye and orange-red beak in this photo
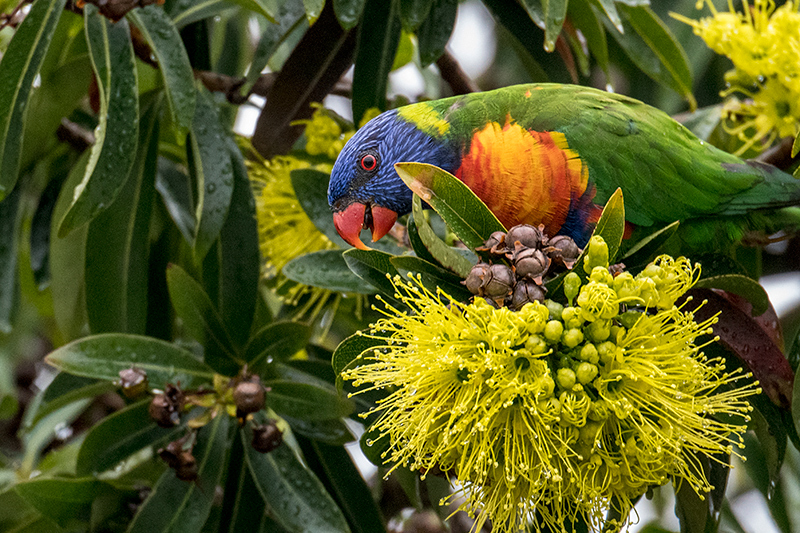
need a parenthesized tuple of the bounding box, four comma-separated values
(328, 110, 458, 248)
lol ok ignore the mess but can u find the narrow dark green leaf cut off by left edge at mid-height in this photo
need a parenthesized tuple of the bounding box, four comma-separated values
(0, 185, 22, 333)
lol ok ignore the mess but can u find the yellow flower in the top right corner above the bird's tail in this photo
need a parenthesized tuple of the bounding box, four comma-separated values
(673, 0, 800, 154)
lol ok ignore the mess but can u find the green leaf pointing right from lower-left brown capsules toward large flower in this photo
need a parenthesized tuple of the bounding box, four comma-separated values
(264, 379, 353, 421)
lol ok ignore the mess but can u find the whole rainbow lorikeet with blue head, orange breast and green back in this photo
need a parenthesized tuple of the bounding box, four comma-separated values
(328, 84, 800, 248)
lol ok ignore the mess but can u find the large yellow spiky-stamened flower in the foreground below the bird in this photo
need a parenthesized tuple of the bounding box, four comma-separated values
(342, 238, 759, 532)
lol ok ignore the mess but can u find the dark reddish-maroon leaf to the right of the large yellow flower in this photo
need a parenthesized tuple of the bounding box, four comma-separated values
(686, 289, 794, 409)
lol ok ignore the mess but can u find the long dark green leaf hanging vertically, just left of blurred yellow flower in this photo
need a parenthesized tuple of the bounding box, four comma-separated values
(206, 139, 261, 346)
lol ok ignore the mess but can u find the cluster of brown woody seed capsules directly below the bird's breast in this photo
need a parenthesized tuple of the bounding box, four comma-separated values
(464, 224, 581, 310)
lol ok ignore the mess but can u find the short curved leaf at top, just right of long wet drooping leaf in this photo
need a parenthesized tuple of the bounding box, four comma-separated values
(127, 5, 195, 128)
